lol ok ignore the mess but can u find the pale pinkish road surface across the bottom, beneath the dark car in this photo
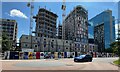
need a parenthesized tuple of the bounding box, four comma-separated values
(1, 58, 118, 70)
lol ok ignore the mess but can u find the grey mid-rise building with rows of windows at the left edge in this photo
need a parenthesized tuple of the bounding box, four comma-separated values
(0, 19, 18, 47)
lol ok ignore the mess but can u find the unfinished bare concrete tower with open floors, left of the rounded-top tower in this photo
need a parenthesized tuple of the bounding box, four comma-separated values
(34, 8, 58, 38)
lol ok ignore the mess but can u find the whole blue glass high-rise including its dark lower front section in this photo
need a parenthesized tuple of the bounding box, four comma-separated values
(89, 10, 115, 52)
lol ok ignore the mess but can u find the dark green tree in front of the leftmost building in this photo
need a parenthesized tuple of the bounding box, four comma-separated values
(2, 32, 12, 52)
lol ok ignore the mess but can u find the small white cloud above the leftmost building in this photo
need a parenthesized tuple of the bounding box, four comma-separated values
(9, 9, 28, 19)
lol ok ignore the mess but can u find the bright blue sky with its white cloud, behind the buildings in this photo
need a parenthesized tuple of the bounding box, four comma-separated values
(2, 2, 118, 42)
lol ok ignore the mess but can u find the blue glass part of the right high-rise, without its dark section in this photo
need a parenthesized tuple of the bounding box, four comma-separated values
(89, 10, 115, 51)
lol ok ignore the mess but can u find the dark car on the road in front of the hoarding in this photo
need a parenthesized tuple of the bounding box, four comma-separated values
(74, 54, 92, 62)
